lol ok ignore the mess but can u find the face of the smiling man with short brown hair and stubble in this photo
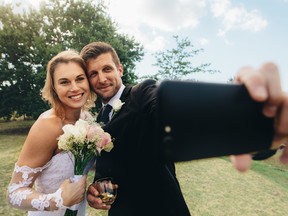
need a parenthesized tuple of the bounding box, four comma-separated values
(87, 53, 123, 103)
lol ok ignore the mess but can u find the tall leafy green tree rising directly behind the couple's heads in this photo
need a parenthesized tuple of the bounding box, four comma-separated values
(36, 0, 144, 84)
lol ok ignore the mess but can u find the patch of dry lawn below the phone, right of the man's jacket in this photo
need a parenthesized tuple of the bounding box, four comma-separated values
(177, 156, 288, 216)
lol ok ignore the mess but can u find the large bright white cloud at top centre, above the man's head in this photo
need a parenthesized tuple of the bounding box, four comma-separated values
(107, 0, 206, 51)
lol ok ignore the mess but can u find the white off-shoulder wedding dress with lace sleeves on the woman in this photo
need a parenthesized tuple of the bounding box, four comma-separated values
(8, 152, 86, 216)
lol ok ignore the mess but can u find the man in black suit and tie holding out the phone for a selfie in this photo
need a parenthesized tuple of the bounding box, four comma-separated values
(80, 42, 288, 216)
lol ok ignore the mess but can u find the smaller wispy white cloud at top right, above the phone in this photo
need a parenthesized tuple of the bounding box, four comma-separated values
(210, 0, 268, 36)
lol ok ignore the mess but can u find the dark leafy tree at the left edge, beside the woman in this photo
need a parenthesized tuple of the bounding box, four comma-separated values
(0, 4, 45, 119)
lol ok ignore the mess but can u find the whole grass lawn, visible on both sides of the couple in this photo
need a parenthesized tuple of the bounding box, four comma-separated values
(0, 121, 288, 216)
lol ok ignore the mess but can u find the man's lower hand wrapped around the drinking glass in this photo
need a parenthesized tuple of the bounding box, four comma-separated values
(87, 184, 111, 210)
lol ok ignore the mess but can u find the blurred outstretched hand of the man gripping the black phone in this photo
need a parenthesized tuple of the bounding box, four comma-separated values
(231, 63, 288, 171)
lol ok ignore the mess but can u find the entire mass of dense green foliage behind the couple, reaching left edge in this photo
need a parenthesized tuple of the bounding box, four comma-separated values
(0, 0, 144, 119)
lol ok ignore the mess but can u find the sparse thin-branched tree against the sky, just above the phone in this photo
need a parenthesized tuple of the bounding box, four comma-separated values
(145, 36, 216, 80)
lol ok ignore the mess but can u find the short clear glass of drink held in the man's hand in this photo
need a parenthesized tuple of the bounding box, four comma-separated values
(95, 177, 117, 205)
